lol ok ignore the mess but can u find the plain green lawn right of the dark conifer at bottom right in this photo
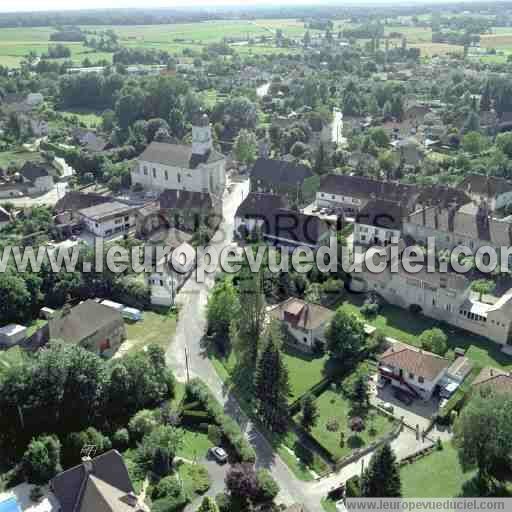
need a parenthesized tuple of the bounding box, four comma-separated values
(400, 443, 475, 498)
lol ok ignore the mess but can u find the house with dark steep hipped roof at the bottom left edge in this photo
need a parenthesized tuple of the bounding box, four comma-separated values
(50, 450, 148, 512)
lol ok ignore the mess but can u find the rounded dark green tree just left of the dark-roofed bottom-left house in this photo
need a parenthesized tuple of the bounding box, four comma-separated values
(22, 436, 62, 485)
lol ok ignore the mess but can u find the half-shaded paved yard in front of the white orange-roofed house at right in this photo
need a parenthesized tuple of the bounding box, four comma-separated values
(370, 375, 439, 430)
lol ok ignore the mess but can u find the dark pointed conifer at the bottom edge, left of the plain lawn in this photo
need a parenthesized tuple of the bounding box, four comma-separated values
(361, 444, 402, 498)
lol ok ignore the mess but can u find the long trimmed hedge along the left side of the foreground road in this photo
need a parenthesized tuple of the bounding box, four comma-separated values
(185, 379, 256, 462)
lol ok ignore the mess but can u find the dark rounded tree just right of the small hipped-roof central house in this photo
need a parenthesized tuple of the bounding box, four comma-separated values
(325, 307, 366, 364)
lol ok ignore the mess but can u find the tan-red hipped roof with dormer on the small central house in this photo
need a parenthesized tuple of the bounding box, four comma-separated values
(270, 297, 334, 330)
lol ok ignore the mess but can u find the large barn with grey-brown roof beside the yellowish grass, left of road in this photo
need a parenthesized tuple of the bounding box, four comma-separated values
(46, 300, 126, 357)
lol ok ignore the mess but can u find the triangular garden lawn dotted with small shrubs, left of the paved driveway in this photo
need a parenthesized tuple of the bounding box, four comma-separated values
(302, 390, 395, 460)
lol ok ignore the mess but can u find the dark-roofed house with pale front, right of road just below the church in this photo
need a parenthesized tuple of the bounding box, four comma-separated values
(235, 192, 287, 236)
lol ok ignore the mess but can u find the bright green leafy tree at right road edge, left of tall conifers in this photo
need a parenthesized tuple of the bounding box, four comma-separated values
(207, 279, 240, 337)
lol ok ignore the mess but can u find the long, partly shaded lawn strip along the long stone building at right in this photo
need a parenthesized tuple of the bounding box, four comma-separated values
(341, 294, 512, 370)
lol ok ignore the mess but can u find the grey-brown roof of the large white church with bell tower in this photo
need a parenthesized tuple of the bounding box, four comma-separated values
(138, 142, 224, 169)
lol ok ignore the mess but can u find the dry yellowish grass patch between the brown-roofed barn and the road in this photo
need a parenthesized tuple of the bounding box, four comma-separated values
(125, 311, 176, 352)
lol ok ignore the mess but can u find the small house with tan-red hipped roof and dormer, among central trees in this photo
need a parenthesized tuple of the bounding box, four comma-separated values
(269, 297, 334, 352)
